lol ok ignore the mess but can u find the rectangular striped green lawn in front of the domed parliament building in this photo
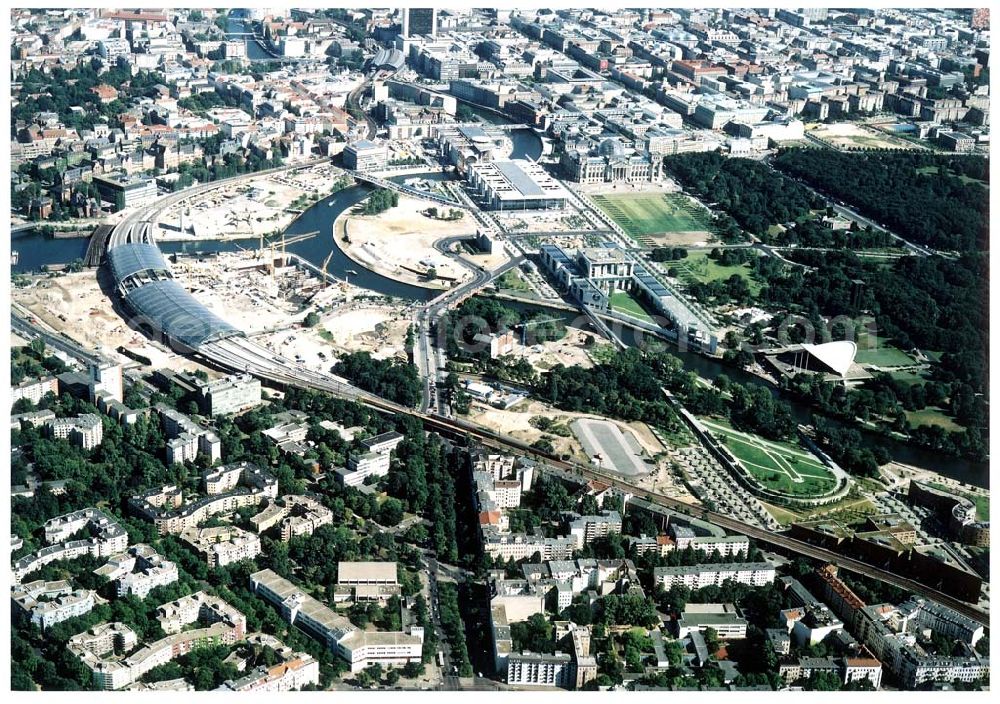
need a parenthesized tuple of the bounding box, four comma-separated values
(591, 193, 709, 245)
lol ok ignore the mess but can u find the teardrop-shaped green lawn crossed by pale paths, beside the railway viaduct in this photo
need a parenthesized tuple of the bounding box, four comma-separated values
(701, 418, 837, 497)
